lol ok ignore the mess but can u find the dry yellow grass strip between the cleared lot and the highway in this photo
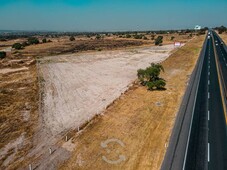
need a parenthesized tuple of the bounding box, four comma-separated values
(60, 36, 204, 170)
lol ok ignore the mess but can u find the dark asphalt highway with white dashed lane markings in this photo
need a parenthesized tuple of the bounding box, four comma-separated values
(162, 30, 227, 170)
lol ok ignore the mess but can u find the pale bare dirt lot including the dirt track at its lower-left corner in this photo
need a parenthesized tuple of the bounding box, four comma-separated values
(11, 45, 176, 169)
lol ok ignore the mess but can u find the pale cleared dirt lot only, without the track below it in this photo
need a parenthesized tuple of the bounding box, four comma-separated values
(40, 45, 174, 135)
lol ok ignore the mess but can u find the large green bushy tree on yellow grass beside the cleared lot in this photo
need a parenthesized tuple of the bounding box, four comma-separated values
(137, 63, 166, 90)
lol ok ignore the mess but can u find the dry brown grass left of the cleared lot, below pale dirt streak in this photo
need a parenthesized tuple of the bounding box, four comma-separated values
(0, 65, 38, 169)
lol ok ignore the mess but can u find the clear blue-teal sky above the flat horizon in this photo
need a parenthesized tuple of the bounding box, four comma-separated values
(0, 0, 227, 31)
